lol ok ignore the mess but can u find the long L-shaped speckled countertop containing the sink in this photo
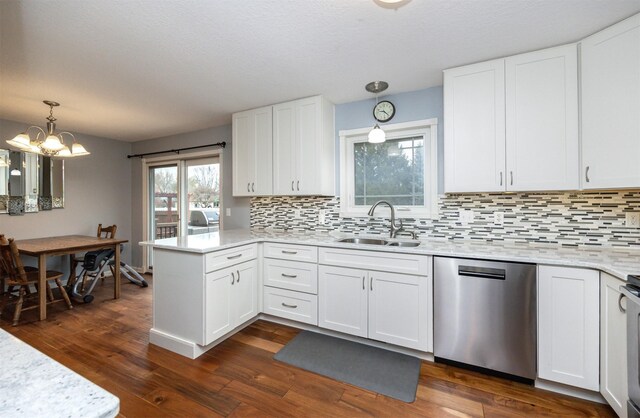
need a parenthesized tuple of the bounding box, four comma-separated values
(140, 229, 640, 280)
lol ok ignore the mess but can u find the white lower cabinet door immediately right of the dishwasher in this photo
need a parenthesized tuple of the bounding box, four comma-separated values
(538, 266, 600, 391)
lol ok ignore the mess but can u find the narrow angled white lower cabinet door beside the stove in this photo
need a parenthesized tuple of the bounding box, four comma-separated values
(600, 273, 628, 417)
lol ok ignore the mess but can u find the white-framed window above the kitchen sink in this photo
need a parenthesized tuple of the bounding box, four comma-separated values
(340, 119, 437, 218)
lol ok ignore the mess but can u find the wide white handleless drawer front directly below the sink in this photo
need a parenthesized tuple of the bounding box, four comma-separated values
(318, 248, 432, 277)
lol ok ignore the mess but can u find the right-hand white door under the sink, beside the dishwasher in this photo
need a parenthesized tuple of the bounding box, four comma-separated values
(369, 271, 432, 351)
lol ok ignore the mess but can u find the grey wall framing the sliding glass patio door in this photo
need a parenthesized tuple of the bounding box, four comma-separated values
(131, 125, 249, 266)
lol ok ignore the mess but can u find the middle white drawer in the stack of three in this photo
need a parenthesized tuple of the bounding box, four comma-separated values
(264, 258, 318, 295)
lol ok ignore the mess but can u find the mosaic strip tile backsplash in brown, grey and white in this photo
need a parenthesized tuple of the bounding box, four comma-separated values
(250, 190, 640, 248)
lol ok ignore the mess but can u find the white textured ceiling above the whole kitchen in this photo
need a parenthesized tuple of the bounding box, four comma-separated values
(0, 0, 640, 141)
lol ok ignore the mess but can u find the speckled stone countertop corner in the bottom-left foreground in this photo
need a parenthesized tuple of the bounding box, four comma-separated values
(0, 329, 120, 418)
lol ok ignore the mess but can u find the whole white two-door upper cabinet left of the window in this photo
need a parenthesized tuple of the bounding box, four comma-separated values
(233, 96, 335, 196)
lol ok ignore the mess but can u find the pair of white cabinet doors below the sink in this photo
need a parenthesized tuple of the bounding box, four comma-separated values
(318, 266, 433, 351)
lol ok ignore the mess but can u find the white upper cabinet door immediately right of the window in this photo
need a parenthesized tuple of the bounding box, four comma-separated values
(444, 59, 506, 193)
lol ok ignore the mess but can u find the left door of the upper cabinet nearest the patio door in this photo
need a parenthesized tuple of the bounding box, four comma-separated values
(231, 106, 273, 196)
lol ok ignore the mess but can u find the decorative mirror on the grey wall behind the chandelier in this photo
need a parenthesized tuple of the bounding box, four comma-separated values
(0, 149, 64, 215)
